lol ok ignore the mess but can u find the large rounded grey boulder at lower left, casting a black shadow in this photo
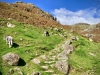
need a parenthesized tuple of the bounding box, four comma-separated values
(2, 53, 20, 66)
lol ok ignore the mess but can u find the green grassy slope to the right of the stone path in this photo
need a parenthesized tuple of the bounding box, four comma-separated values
(69, 37, 100, 75)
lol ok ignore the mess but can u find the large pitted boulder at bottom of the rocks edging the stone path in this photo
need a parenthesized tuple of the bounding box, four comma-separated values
(55, 60, 69, 75)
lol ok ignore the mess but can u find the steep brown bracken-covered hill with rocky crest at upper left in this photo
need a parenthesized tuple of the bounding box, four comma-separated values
(0, 2, 60, 26)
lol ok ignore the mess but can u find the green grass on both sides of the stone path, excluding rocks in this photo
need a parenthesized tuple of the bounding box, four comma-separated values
(0, 17, 100, 75)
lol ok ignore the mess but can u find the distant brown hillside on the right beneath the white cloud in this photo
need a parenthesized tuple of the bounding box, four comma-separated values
(71, 23, 100, 42)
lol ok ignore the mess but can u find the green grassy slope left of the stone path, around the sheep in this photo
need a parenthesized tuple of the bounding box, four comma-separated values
(0, 19, 64, 75)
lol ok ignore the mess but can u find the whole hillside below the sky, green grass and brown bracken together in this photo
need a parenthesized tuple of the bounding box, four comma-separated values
(0, 2, 100, 75)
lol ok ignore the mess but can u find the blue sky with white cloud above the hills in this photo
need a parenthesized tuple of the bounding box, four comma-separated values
(0, 0, 100, 25)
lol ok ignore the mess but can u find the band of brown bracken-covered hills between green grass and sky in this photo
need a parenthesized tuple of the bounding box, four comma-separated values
(0, 2, 100, 42)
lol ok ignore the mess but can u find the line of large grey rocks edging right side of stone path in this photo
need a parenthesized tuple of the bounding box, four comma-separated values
(55, 40, 73, 75)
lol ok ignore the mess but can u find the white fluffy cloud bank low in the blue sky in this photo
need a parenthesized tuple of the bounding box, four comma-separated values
(51, 8, 100, 25)
